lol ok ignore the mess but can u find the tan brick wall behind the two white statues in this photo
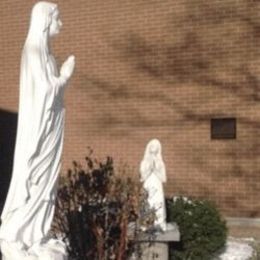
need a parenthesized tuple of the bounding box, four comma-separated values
(0, 0, 260, 217)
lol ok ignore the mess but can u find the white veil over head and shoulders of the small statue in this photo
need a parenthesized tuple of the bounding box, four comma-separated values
(140, 139, 166, 182)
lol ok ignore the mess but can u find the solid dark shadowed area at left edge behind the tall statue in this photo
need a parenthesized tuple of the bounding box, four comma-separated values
(0, 109, 17, 215)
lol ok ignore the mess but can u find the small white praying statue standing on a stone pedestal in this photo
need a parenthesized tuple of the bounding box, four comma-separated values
(140, 139, 167, 231)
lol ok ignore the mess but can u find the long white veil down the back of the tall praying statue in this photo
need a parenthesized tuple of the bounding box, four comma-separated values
(1, 2, 57, 220)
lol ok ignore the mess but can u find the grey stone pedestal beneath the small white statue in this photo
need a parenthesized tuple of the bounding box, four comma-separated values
(130, 223, 180, 260)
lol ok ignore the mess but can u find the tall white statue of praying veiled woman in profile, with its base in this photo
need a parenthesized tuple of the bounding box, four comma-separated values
(0, 2, 75, 260)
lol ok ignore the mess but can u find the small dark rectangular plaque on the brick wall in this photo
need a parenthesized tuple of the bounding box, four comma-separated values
(211, 118, 236, 139)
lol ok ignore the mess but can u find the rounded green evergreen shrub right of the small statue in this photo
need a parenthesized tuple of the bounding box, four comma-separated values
(167, 197, 227, 260)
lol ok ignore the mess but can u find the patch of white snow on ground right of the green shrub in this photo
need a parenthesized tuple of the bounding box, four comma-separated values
(219, 238, 254, 260)
